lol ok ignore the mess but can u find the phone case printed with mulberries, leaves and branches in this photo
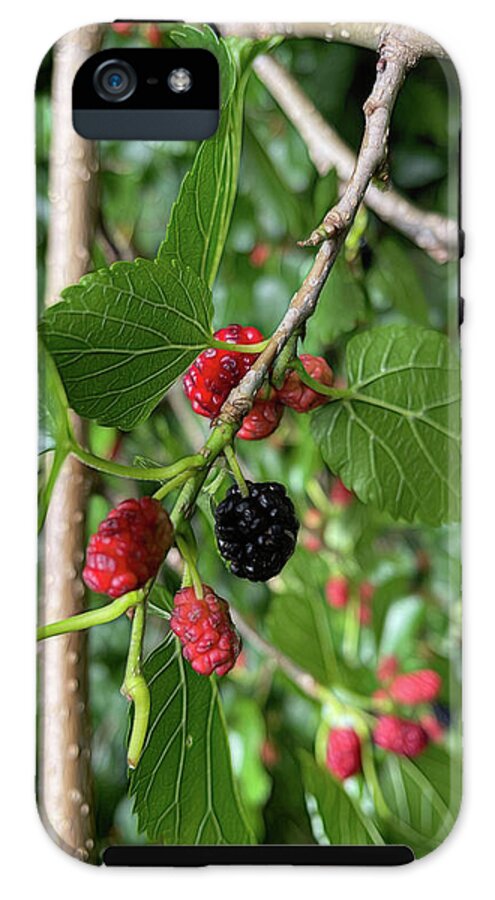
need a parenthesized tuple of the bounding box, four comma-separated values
(36, 22, 462, 865)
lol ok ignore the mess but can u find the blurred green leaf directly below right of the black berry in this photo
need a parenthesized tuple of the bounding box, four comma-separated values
(267, 547, 338, 685)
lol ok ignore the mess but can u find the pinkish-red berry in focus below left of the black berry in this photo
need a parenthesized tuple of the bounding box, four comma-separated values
(170, 584, 241, 675)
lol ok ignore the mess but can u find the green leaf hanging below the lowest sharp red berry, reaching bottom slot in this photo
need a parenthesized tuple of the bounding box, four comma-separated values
(130, 635, 253, 844)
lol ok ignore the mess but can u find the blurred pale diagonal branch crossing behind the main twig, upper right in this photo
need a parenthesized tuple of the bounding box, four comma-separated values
(253, 56, 459, 263)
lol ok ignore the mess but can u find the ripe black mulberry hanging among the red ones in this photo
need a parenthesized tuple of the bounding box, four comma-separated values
(215, 481, 299, 581)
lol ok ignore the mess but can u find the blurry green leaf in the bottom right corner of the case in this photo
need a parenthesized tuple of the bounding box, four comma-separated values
(379, 746, 460, 857)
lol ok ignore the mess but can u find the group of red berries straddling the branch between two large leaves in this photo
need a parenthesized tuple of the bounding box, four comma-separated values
(184, 325, 333, 441)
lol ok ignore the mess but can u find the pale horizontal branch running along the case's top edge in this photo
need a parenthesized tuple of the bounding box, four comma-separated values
(218, 22, 448, 59)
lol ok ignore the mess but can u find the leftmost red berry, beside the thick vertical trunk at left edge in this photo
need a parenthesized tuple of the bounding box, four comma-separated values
(83, 497, 172, 598)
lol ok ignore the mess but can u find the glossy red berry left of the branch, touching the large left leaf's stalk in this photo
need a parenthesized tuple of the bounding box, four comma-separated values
(184, 325, 263, 419)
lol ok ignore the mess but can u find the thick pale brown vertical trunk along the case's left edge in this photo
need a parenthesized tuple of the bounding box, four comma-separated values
(38, 26, 101, 862)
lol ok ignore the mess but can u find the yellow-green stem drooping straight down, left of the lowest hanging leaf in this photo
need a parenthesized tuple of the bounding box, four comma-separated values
(121, 602, 150, 769)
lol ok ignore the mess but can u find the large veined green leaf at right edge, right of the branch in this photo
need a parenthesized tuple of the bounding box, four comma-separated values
(312, 325, 460, 525)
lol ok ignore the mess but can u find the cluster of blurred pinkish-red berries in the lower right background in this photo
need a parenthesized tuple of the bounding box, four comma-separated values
(326, 656, 443, 780)
